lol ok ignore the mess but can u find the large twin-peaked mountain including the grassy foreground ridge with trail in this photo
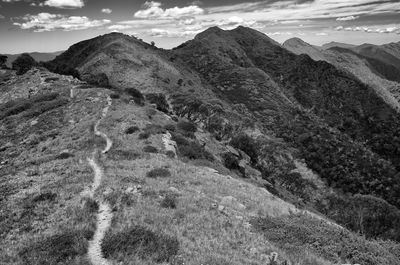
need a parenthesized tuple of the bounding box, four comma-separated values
(0, 27, 400, 265)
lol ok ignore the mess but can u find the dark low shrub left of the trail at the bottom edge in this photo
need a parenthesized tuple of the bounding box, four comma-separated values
(19, 230, 93, 265)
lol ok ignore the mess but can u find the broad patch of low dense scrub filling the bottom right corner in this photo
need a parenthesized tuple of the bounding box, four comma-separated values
(252, 215, 400, 265)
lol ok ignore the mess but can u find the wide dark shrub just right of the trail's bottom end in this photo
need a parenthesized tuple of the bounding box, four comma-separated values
(101, 226, 179, 263)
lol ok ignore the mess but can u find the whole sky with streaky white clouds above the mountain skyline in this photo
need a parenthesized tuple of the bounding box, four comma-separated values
(0, 0, 400, 53)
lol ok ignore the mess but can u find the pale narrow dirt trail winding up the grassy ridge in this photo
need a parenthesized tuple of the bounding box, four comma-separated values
(84, 96, 112, 265)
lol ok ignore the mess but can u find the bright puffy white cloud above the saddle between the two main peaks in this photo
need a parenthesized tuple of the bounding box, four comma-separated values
(134, 1, 204, 19)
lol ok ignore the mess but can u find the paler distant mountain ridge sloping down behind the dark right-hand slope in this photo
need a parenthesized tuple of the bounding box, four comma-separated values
(283, 38, 400, 110)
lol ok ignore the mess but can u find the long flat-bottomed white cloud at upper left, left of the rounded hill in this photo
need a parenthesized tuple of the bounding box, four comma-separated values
(13, 13, 111, 32)
